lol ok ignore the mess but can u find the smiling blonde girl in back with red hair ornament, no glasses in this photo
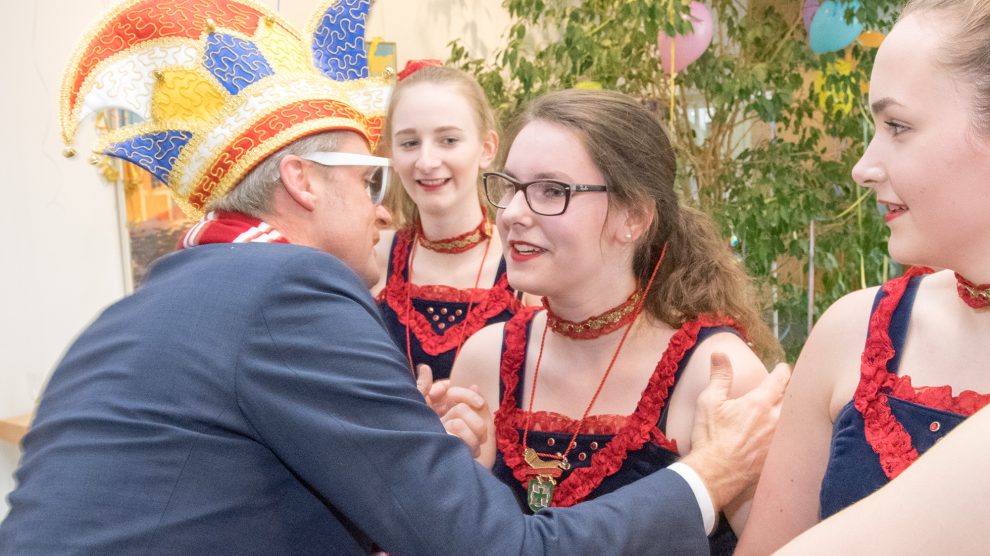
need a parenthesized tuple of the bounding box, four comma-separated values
(372, 60, 521, 381)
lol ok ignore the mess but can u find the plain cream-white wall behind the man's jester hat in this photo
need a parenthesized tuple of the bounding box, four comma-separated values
(0, 0, 509, 517)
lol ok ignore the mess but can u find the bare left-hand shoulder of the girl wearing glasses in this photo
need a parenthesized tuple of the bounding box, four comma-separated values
(450, 323, 505, 408)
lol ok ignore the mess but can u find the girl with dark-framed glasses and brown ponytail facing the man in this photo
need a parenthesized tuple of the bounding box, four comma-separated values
(451, 90, 779, 553)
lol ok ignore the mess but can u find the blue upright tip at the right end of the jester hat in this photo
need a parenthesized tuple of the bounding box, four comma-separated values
(312, 0, 370, 81)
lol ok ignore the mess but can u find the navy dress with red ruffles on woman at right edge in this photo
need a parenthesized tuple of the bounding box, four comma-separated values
(819, 269, 986, 519)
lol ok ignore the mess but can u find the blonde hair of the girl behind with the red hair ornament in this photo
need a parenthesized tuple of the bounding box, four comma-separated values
(382, 66, 498, 228)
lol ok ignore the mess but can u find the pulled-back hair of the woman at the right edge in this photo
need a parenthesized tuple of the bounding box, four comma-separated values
(900, 0, 990, 136)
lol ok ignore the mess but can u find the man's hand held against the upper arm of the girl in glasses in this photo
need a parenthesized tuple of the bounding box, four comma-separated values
(681, 353, 791, 511)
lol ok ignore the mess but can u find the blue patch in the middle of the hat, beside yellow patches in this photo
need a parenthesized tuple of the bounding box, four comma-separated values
(203, 33, 275, 95)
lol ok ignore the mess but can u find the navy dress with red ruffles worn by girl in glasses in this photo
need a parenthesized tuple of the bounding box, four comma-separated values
(492, 308, 742, 554)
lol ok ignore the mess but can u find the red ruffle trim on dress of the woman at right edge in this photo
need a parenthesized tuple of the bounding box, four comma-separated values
(853, 267, 990, 479)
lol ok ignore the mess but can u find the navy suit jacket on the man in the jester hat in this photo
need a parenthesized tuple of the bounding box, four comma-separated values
(0, 244, 708, 555)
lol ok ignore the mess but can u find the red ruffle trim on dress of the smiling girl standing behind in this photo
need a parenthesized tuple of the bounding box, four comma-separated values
(378, 228, 522, 355)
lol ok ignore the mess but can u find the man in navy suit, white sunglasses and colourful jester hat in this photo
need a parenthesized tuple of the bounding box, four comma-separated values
(0, 1, 786, 555)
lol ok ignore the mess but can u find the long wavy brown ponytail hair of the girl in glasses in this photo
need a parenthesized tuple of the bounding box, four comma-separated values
(506, 89, 782, 362)
